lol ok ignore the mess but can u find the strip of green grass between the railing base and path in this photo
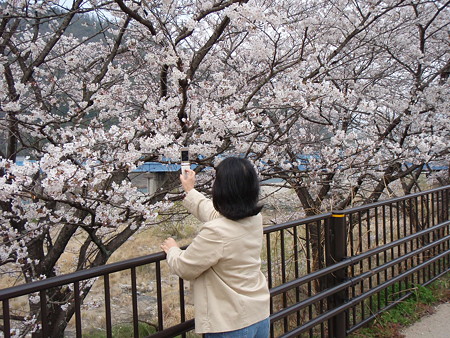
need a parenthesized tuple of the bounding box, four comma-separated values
(350, 274, 450, 338)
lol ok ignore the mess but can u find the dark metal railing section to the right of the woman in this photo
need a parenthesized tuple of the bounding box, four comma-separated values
(266, 186, 450, 337)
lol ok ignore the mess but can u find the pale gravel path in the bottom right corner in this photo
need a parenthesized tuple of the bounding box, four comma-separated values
(402, 302, 450, 338)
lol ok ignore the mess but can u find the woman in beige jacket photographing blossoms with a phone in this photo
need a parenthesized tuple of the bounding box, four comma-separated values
(161, 157, 270, 338)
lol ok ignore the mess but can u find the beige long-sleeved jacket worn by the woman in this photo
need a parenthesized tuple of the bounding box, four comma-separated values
(167, 190, 270, 333)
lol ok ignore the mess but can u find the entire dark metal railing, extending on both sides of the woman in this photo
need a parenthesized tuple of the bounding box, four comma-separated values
(0, 186, 450, 337)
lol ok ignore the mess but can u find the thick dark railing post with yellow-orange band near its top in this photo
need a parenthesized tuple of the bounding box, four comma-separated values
(327, 211, 348, 338)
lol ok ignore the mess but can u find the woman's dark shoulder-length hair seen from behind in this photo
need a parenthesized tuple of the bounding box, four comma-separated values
(212, 157, 262, 220)
